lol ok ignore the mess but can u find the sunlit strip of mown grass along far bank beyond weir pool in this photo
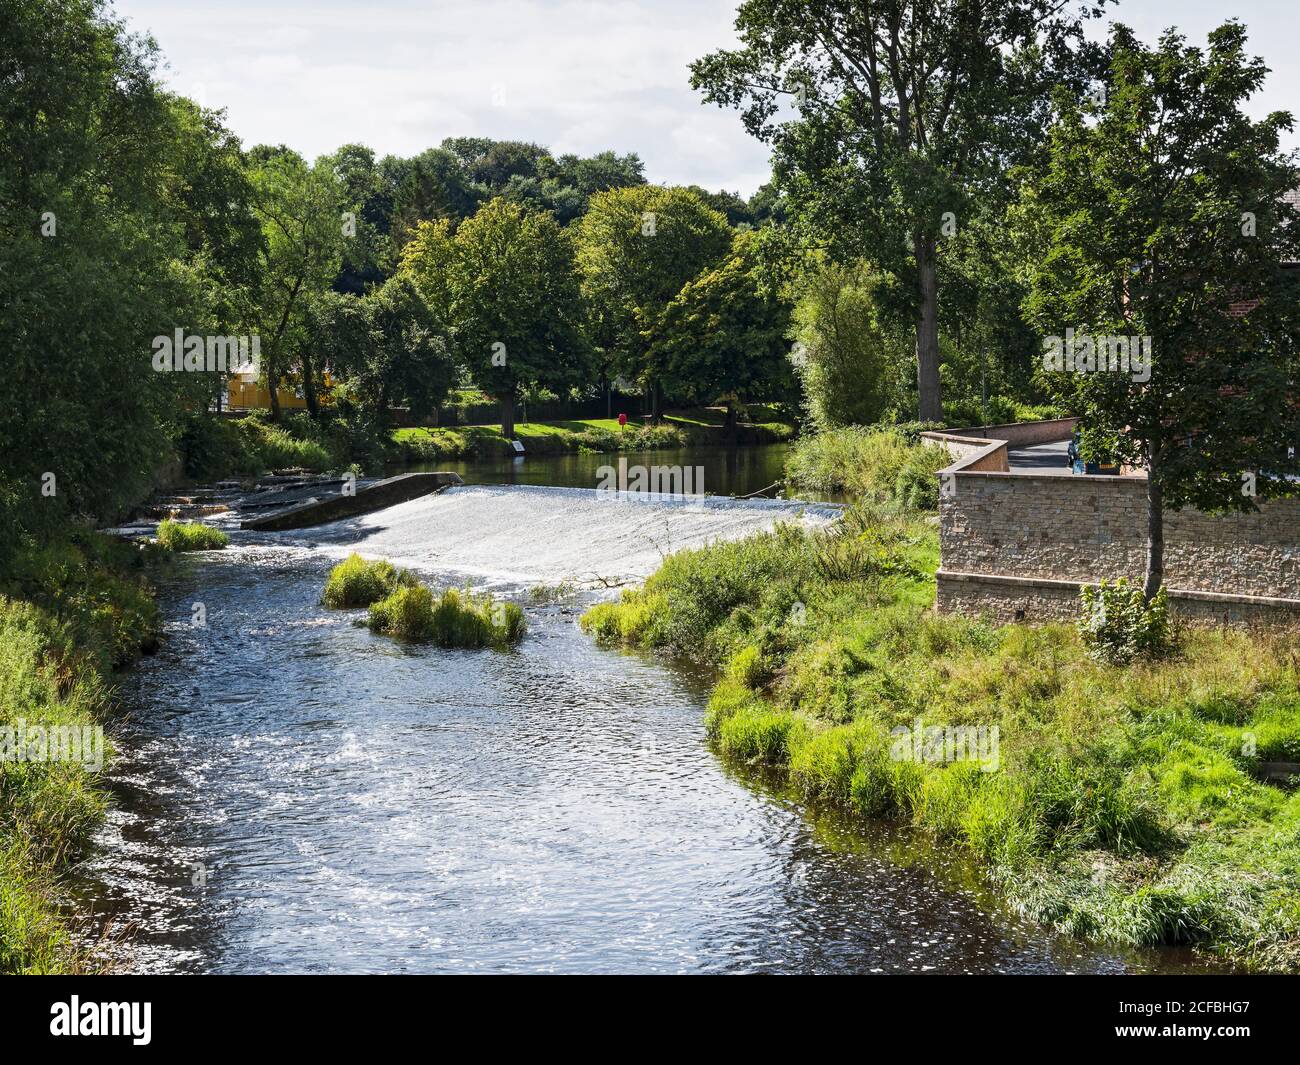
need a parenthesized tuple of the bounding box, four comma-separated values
(393, 407, 794, 463)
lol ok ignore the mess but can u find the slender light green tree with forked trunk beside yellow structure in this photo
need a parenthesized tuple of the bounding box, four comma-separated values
(252, 150, 355, 419)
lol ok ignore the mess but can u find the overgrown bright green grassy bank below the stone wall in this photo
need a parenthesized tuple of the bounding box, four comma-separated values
(582, 507, 1300, 971)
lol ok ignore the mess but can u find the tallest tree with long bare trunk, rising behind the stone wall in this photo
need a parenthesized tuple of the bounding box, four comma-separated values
(692, 0, 1104, 421)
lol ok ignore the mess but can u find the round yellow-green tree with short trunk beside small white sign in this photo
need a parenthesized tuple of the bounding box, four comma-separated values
(402, 198, 589, 437)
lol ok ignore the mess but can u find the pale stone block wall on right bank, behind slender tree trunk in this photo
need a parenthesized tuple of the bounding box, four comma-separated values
(936, 423, 1300, 622)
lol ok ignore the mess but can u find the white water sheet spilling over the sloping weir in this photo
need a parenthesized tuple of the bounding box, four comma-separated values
(279, 485, 840, 585)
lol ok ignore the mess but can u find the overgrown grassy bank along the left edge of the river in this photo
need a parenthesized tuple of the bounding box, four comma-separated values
(0, 534, 159, 973)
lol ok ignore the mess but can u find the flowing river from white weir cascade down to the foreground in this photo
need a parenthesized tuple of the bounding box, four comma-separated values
(79, 462, 1216, 973)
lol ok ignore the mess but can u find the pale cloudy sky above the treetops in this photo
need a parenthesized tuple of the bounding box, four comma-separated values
(113, 0, 1300, 196)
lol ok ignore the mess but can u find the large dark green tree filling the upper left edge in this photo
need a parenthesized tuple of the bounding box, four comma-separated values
(0, 0, 248, 557)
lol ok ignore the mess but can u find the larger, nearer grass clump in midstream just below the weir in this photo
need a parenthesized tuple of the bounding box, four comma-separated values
(369, 584, 524, 648)
